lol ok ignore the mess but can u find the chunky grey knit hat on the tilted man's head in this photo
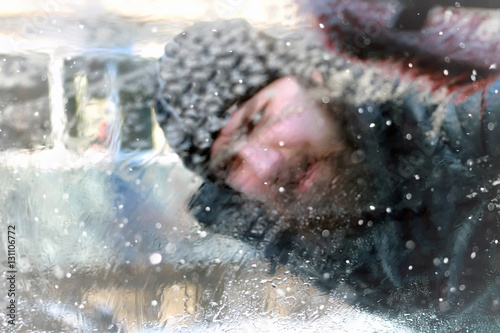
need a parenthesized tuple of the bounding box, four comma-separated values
(156, 20, 342, 176)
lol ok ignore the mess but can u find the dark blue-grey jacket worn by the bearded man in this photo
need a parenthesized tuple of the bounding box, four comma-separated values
(191, 75, 500, 324)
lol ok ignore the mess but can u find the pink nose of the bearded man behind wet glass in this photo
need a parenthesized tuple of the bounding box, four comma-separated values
(239, 144, 283, 182)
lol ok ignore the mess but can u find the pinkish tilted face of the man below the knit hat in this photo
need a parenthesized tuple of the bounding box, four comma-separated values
(210, 77, 344, 203)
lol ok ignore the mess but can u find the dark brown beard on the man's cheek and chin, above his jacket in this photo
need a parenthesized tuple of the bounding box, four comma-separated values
(254, 151, 378, 230)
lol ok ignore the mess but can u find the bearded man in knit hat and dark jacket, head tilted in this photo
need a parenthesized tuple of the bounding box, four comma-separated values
(157, 20, 500, 324)
